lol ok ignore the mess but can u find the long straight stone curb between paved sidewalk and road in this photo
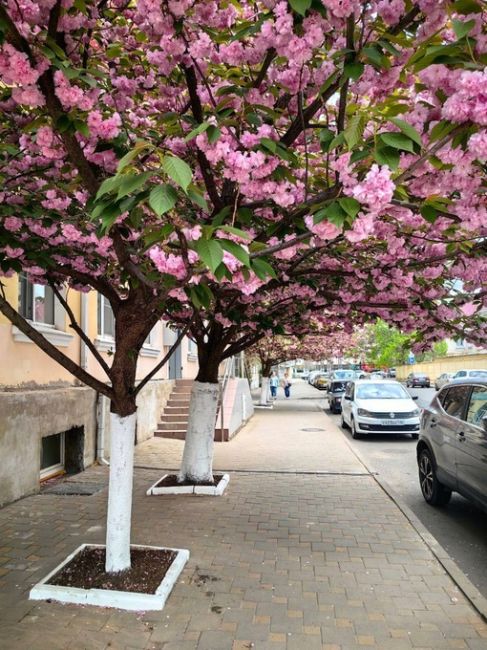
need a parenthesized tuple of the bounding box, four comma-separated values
(337, 426, 487, 622)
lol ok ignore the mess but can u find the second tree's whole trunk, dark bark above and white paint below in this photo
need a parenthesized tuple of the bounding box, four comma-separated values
(178, 331, 223, 483)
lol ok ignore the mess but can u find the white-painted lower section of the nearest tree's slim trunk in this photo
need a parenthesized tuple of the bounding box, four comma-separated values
(105, 413, 137, 573)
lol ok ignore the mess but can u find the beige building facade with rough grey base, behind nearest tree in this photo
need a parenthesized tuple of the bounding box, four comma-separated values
(0, 276, 198, 505)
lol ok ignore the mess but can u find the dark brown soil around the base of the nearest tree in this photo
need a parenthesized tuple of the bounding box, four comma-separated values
(48, 547, 176, 594)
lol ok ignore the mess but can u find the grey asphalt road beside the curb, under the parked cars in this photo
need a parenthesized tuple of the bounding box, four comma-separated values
(324, 388, 487, 597)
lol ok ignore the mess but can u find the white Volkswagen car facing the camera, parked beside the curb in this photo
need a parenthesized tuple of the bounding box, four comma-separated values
(341, 379, 421, 439)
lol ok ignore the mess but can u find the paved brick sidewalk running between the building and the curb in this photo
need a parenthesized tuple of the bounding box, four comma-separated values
(0, 382, 487, 650)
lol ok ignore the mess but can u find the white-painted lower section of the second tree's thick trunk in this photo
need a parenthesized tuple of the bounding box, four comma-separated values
(178, 381, 220, 483)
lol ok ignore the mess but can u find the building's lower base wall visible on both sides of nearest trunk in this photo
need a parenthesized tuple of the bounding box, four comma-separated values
(0, 379, 174, 506)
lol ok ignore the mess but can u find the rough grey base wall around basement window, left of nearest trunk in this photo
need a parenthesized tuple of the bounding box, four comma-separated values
(0, 387, 96, 506)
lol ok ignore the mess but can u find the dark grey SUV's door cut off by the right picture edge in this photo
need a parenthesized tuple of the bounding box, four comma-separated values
(456, 386, 487, 506)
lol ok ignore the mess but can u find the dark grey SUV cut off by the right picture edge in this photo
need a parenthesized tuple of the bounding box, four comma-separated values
(417, 378, 487, 512)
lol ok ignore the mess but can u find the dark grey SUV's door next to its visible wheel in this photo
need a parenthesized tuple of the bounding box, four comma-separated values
(432, 386, 470, 488)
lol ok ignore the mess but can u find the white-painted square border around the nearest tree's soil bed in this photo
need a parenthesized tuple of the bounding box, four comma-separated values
(29, 544, 189, 611)
